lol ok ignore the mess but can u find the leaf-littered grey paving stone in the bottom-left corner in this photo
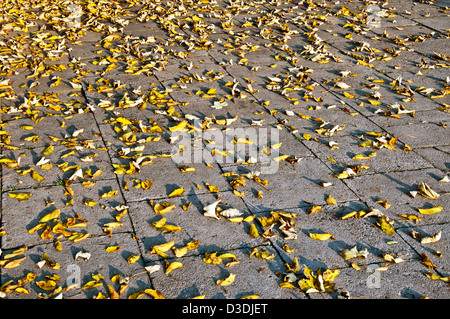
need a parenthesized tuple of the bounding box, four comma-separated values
(1, 233, 152, 299)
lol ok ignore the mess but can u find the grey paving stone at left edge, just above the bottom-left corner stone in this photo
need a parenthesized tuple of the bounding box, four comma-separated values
(2, 180, 131, 248)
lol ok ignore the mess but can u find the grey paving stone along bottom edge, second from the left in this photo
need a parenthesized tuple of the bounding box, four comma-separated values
(152, 247, 294, 299)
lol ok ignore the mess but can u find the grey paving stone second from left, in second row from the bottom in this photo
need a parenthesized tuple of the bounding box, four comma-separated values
(129, 192, 263, 261)
